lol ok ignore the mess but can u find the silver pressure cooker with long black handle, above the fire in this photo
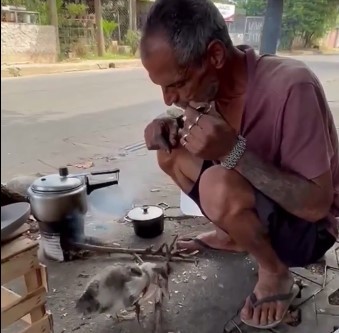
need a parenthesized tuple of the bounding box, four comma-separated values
(28, 167, 120, 223)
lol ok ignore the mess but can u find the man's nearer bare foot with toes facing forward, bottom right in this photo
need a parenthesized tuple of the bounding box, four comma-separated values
(240, 269, 294, 326)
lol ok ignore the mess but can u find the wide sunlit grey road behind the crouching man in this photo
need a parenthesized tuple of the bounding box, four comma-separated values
(1, 56, 339, 181)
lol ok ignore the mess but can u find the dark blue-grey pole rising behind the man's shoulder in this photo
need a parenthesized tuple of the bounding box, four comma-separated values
(260, 0, 284, 54)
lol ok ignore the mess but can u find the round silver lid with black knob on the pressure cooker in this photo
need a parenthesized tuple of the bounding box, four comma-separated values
(31, 169, 83, 192)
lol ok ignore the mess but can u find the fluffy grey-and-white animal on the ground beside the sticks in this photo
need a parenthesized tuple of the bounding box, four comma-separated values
(75, 262, 170, 322)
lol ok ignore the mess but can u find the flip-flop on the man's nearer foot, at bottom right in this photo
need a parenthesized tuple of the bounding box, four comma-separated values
(241, 283, 300, 330)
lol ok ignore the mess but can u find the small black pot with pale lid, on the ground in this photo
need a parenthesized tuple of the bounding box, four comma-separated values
(126, 205, 165, 238)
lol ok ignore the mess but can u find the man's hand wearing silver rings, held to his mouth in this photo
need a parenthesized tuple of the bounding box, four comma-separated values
(180, 104, 237, 160)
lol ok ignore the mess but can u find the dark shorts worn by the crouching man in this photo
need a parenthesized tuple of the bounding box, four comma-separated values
(189, 161, 336, 267)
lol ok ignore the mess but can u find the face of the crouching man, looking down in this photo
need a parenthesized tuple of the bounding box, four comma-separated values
(142, 36, 223, 108)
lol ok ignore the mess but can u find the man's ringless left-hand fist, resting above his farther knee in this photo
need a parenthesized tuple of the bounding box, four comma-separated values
(144, 117, 179, 153)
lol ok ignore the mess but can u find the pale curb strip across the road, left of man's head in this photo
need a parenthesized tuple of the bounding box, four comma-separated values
(1, 59, 142, 78)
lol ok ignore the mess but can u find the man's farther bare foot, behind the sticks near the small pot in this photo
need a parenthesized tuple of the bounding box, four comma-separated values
(177, 230, 244, 252)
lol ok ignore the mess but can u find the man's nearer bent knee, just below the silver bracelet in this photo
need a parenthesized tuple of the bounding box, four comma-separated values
(199, 165, 255, 224)
